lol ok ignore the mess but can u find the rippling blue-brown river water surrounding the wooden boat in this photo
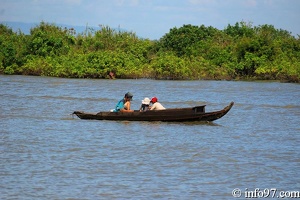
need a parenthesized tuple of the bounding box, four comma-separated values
(0, 76, 300, 200)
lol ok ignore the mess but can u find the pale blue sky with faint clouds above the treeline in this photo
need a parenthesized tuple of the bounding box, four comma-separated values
(0, 0, 300, 40)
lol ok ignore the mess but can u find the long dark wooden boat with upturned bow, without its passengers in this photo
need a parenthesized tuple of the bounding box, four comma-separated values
(73, 102, 234, 122)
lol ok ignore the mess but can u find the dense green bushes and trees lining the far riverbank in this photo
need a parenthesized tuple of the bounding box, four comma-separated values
(0, 22, 300, 82)
